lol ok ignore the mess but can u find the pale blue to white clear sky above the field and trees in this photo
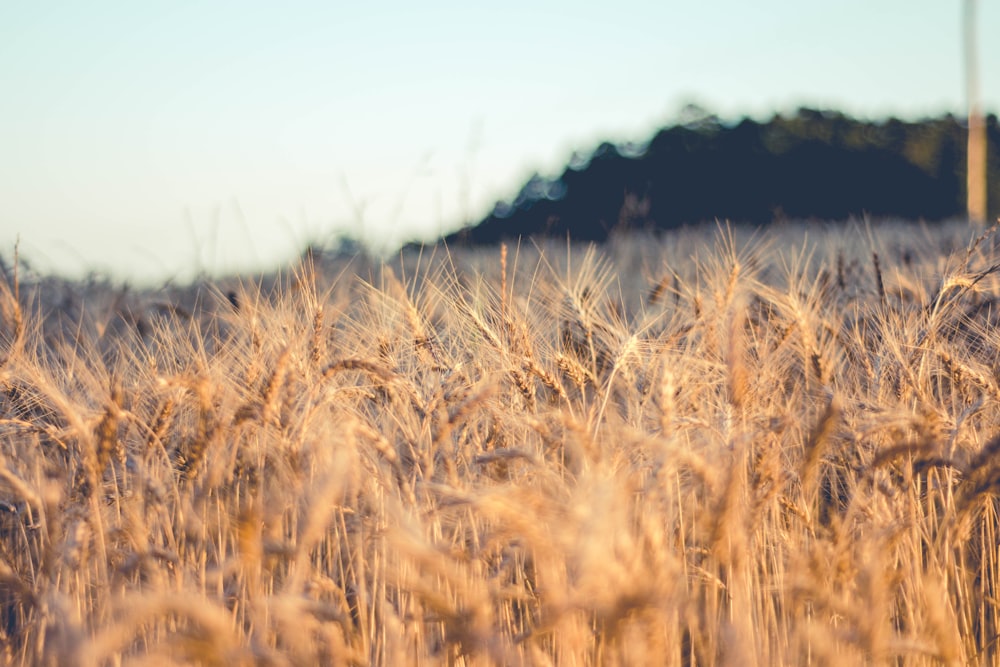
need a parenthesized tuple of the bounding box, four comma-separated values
(0, 0, 1000, 281)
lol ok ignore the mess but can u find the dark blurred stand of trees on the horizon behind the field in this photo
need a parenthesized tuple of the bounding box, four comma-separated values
(447, 108, 1000, 243)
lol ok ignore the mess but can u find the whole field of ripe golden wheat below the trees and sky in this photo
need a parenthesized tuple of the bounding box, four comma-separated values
(0, 218, 1000, 666)
